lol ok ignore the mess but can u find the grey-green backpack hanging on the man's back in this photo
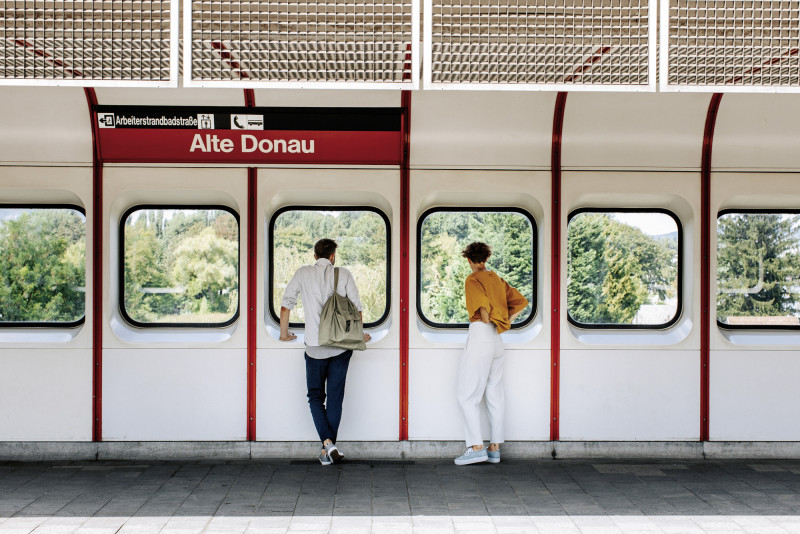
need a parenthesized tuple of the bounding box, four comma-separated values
(319, 267, 367, 350)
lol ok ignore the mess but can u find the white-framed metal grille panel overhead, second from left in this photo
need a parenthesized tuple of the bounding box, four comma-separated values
(184, 0, 419, 89)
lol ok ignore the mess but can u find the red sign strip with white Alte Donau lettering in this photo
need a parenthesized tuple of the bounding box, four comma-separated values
(98, 128, 402, 165)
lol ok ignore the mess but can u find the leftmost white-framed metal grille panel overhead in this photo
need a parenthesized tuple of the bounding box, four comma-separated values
(0, 0, 178, 86)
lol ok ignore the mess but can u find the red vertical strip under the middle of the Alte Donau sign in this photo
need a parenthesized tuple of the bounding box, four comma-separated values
(244, 89, 258, 441)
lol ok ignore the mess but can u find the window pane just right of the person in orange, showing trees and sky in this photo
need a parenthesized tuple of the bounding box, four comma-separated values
(567, 209, 681, 328)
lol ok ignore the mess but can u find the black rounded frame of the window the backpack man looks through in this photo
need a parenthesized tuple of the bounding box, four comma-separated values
(265, 205, 392, 328)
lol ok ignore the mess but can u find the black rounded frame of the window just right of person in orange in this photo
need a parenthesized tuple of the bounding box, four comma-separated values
(564, 207, 684, 331)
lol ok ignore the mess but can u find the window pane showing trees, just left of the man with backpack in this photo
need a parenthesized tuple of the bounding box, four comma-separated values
(120, 206, 239, 327)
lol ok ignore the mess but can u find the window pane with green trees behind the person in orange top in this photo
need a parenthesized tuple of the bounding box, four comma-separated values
(417, 208, 536, 328)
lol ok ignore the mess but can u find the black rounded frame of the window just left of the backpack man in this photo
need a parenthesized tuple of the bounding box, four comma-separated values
(117, 204, 242, 329)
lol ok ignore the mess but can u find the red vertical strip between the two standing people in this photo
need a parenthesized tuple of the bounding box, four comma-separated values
(400, 91, 411, 441)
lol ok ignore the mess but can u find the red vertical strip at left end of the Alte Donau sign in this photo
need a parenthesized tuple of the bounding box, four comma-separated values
(84, 87, 103, 441)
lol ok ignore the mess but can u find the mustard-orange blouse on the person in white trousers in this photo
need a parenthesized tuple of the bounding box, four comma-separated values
(464, 271, 528, 333)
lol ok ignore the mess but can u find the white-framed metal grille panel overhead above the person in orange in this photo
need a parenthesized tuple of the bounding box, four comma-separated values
(424, 0, 656, 91)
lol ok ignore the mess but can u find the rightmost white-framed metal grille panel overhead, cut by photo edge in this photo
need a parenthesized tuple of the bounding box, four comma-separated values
(660, 0, 800, 92)
